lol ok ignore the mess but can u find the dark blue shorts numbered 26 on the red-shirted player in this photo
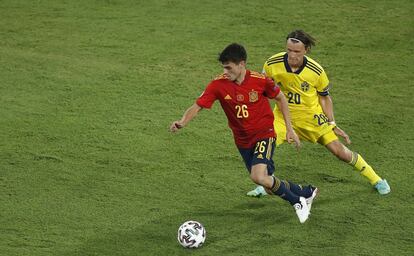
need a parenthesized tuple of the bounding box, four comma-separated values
(238, 138, 276, 175)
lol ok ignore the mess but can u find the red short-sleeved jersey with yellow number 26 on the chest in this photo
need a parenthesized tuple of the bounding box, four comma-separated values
(196, 70, 280, 148)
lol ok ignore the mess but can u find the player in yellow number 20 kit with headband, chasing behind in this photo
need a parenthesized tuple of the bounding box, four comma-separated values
(247, 30, 391, 196)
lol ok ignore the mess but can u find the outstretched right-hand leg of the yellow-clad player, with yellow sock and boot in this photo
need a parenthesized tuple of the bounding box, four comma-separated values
(318, 131, 391, 195)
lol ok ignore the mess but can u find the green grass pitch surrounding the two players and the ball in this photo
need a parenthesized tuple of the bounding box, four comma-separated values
(0, 0, 414, 256)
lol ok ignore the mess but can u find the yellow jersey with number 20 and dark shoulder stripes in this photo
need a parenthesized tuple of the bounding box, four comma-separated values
(263, 52, 329, 121)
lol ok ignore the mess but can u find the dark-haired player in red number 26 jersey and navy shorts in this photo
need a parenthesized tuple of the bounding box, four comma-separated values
(170, 44, 318, 223)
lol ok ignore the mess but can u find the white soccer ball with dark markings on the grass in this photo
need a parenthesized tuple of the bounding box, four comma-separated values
(177, 220, 206, 248)
